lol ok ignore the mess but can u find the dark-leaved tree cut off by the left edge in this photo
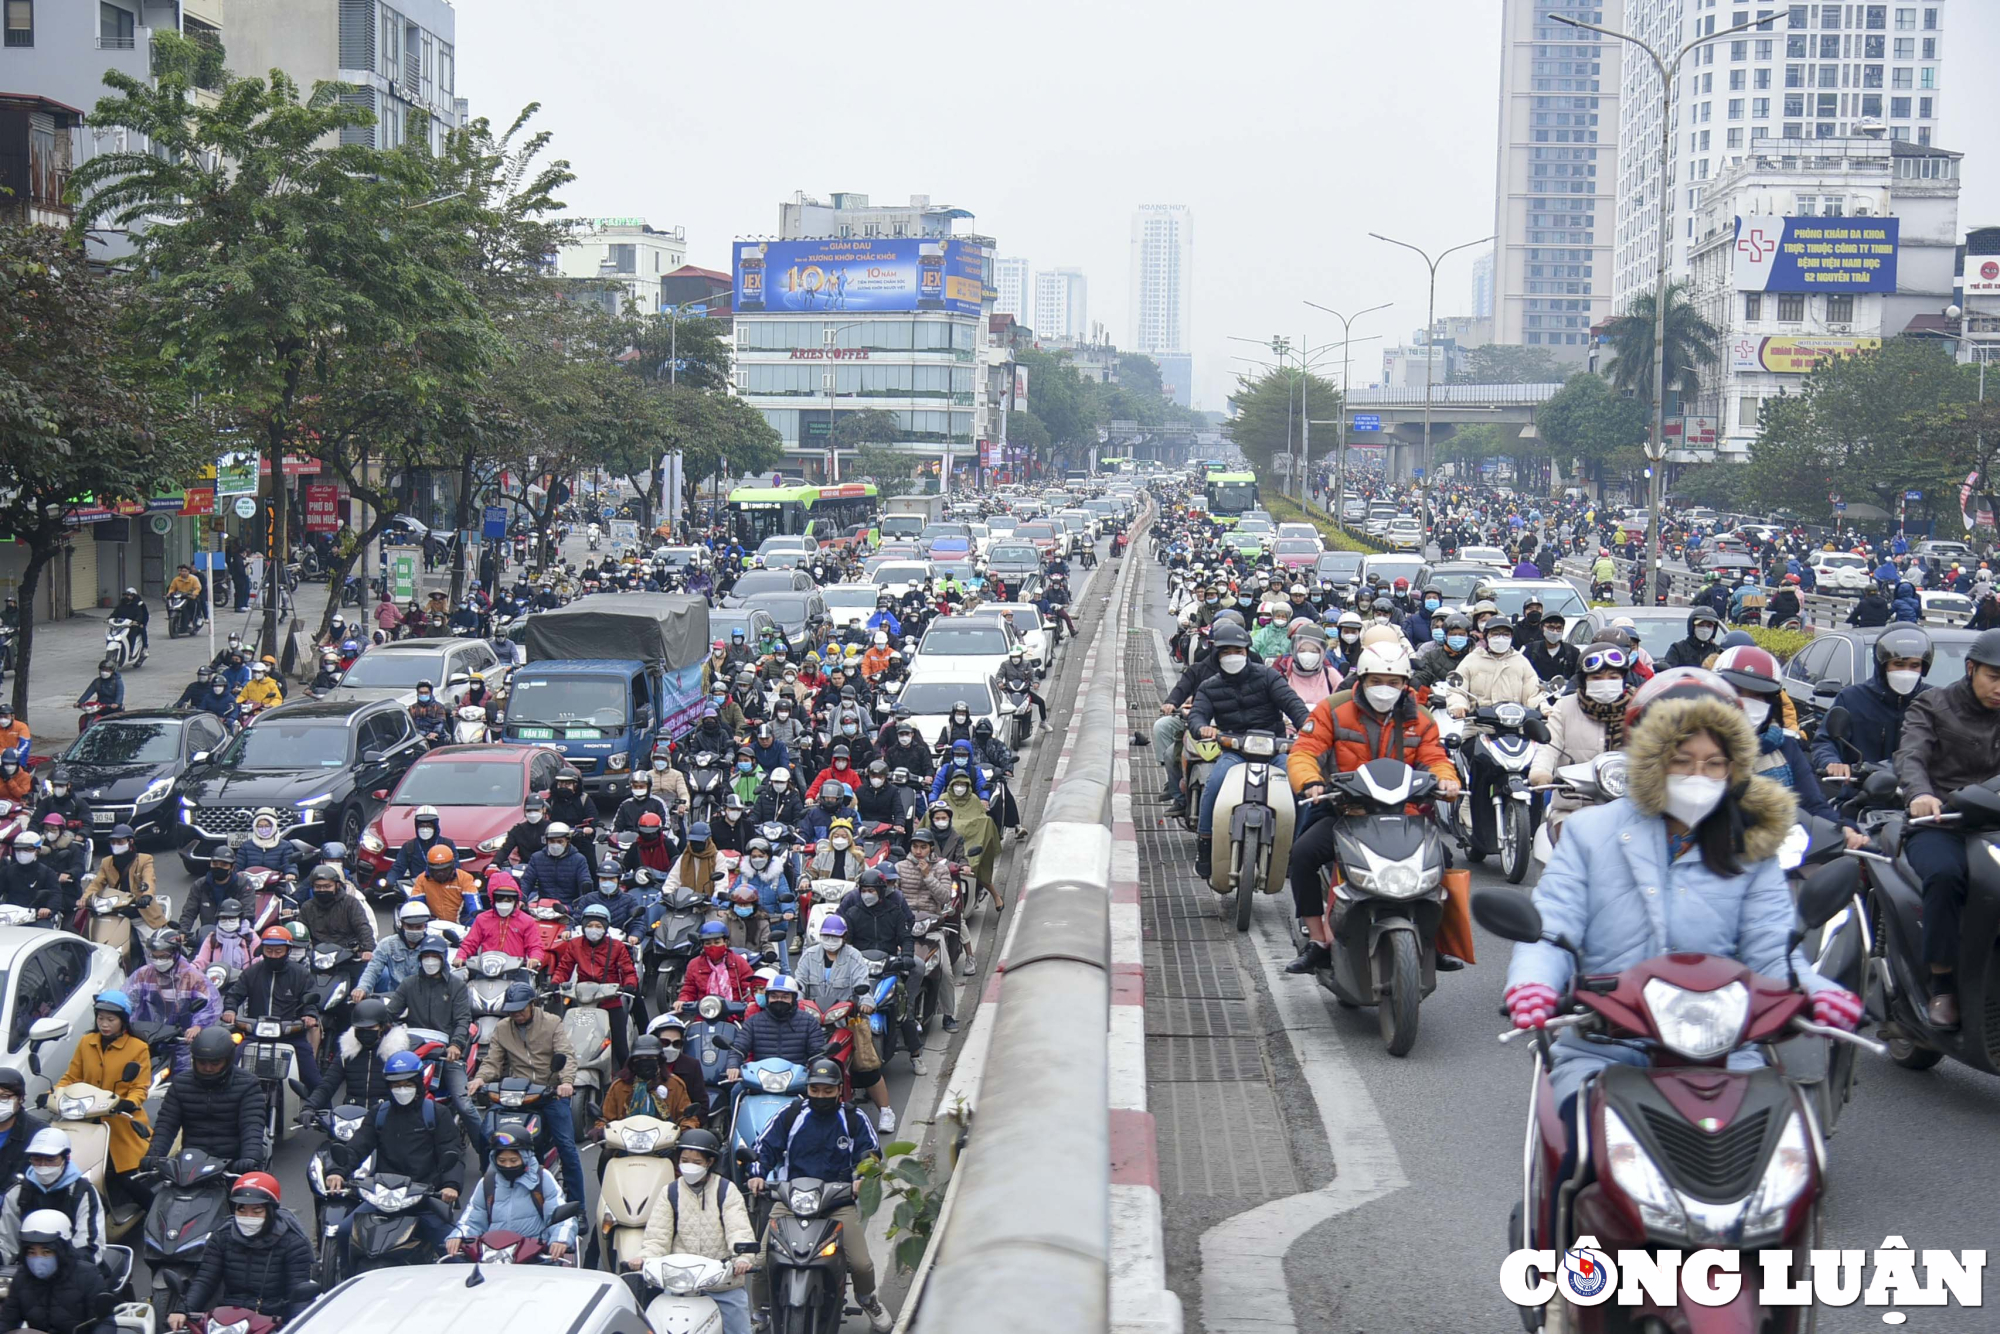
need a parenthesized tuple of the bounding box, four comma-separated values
(0, 226, 201, 722)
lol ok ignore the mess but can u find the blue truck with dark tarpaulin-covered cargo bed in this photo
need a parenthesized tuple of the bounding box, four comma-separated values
(504, 592, 708, 796)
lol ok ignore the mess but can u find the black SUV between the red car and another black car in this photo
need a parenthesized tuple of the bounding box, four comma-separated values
(178, 700, 426, 872)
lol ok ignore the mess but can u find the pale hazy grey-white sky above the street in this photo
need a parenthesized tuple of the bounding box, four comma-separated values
(458, 0, 2000, 410)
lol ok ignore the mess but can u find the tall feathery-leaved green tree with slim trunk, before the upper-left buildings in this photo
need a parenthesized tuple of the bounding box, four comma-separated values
(70, 32, 472, 652)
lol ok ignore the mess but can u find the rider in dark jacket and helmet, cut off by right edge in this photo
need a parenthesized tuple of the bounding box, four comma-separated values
(1896, 630, 2000, 1028)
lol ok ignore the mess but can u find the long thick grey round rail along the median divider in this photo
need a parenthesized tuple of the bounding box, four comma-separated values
(914, 496, 1152, 1334)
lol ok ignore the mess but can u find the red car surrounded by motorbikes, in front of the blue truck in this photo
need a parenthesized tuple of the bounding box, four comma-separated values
(360, 746, 562, 892)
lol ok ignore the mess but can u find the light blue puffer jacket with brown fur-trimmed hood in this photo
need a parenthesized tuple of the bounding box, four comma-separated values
(1506, 700, 1830, 1100)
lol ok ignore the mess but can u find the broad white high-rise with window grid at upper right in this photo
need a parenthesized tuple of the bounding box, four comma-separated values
(1612, 0, 1964, 310)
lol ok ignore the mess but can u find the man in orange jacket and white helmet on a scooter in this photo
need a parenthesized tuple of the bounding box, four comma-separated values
(1286, 636, 1458, 974)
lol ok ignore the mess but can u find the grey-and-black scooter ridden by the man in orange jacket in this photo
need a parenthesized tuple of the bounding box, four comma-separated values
(1314, 758, 1444, 1056)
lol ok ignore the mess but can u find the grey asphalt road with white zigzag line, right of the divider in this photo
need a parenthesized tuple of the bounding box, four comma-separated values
(1134, 556, 2000, 1334)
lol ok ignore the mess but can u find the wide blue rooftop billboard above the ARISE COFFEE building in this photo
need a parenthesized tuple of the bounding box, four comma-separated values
(734, 236, 986, 316)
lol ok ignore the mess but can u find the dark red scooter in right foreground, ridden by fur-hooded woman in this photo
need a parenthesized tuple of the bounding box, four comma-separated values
(1472, 876, 1882, 1334)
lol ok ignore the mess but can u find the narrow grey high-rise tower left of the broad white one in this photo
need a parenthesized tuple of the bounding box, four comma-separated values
(1496, 0, 1634, 362)
